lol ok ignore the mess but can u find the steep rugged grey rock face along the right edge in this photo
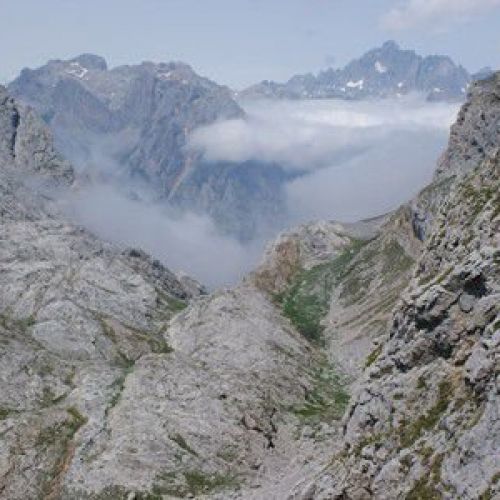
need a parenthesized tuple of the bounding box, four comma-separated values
(288, 74, 500, 499)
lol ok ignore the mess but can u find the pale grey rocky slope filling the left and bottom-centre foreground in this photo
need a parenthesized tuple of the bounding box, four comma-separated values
(0, 89, 347, 500)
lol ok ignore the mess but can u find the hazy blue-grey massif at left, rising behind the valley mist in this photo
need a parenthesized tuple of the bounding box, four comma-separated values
(9, 54, 284, 238)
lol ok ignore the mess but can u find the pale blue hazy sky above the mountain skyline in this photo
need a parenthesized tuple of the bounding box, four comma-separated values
(0, 0, 500, 89)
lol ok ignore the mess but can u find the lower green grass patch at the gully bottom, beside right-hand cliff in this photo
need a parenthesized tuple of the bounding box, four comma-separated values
(293, 363, 349, 422)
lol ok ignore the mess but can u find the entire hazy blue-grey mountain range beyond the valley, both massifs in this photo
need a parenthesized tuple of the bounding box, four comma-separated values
(8, 42, 489, 241)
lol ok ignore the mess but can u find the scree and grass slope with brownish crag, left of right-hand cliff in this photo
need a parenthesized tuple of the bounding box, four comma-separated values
(251, 207, 421, 381)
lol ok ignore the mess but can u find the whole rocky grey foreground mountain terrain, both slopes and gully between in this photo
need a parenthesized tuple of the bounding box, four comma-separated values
(0, 73, 500, 500)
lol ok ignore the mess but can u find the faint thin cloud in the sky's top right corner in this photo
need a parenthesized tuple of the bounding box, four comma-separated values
(382, 0, 500, 31)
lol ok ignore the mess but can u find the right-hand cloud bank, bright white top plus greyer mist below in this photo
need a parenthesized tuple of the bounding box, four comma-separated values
(191, 96, 458, 224)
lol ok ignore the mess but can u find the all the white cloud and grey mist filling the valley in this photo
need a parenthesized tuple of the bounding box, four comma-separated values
(66, 96, 459, 288)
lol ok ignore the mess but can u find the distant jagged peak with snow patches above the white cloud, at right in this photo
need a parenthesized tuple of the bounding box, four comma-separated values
(242, 41, 476, 101)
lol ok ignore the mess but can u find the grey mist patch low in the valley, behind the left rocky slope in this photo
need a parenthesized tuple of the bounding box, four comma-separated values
(66, 185, 263, 287)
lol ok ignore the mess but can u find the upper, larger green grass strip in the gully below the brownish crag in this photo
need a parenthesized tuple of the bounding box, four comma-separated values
(276, 240, 367, 344)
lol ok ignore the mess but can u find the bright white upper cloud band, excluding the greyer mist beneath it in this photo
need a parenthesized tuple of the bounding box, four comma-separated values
(190, 96, 456, 172)
